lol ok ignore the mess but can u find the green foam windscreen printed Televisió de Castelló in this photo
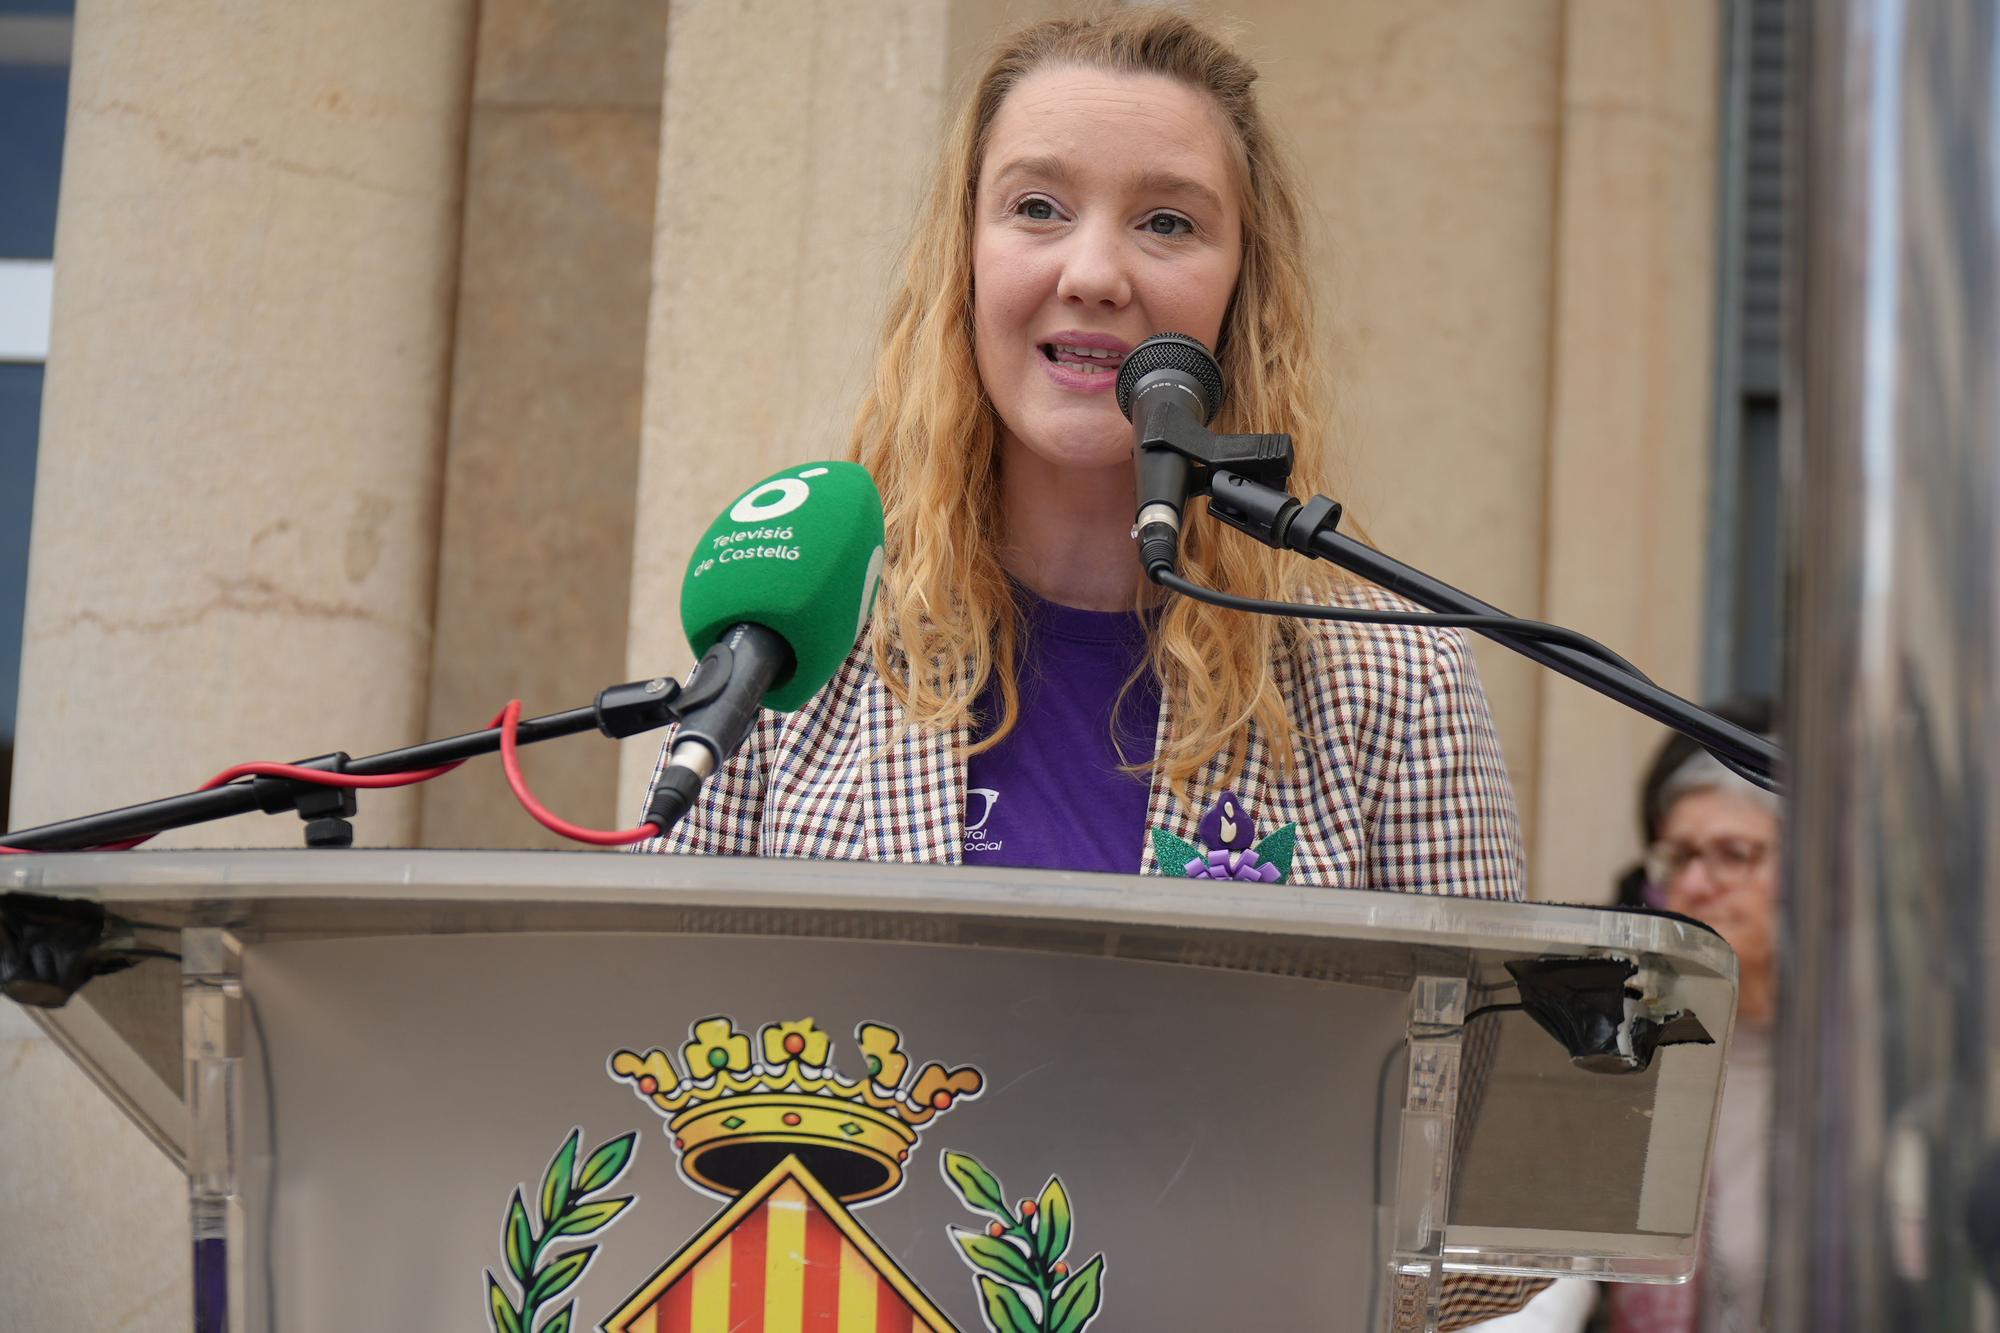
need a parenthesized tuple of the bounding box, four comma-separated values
(680, 462, 882, 713)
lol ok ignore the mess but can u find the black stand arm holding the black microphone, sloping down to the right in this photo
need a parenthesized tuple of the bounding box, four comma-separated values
(1208, 468, 1780, 787)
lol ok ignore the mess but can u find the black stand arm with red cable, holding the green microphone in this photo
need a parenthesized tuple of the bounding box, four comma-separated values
(0, 671, 728, 851)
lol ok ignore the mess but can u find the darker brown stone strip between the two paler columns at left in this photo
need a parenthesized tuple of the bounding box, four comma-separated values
(422, 0, 668, 847)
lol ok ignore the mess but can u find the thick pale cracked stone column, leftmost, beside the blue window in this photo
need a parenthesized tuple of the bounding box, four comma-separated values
(0, 0, 474, 1333)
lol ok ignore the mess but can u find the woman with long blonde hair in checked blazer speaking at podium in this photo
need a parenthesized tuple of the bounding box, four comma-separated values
(652, 6, 1520, 897)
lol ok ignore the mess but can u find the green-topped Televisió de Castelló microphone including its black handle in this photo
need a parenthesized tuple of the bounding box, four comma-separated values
(646, 462, 882, 833)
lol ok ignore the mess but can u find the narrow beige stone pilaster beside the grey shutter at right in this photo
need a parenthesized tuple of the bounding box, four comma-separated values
(1534, 0, 1722, 903)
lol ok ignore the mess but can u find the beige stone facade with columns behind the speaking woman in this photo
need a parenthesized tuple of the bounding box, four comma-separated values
(0, 0, 1720, 1329)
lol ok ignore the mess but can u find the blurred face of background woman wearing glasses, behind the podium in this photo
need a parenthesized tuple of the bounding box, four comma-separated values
(1656, 791, 1778, 975)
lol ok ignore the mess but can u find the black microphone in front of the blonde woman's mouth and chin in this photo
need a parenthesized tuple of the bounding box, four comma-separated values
(1118, 332, 1222, 576)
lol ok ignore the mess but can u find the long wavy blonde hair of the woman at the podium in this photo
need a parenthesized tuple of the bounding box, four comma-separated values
(850, 6, 1342, 793)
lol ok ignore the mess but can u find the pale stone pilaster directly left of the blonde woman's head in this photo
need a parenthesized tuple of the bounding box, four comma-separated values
(622, 0, 952, 821)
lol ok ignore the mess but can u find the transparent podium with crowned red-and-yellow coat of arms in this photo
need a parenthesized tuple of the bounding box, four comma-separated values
(0, 851, 1736, 1333)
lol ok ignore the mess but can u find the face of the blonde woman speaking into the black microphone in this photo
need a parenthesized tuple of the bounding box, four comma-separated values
(972, 68, 1242, 472)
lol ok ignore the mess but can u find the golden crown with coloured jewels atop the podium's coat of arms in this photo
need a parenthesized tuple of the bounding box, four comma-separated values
(612, 1017, 984, 1203)
